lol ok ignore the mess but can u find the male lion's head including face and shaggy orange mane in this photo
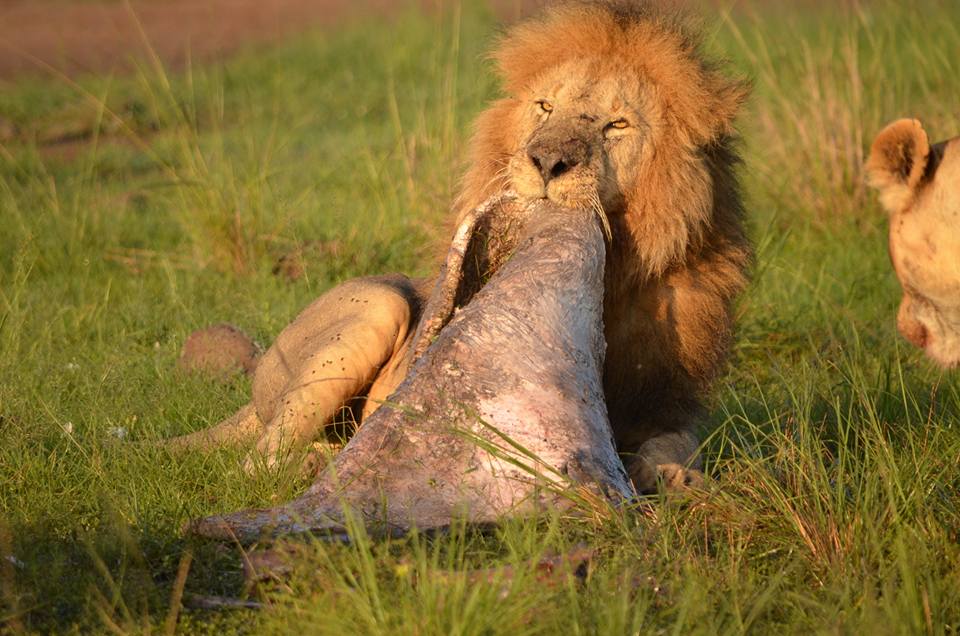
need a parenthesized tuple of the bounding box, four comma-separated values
(461, 1, 747, 277)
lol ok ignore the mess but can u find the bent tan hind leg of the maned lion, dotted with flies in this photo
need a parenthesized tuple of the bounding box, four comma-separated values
(246, 276, 420, 470)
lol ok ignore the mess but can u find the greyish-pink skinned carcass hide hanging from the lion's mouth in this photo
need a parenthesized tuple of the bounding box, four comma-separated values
(189, 199, 633, 543)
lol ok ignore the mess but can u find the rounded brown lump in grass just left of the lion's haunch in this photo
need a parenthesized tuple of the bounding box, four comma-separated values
(177, 324, 261, 379)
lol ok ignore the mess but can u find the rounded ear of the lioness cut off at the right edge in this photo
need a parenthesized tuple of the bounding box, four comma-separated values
(866, 119, 930, 213)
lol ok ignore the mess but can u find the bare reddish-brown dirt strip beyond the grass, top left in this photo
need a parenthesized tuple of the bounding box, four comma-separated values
(0, 0, 540, 79)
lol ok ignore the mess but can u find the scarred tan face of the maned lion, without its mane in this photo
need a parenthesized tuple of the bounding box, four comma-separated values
(507, 60, 647, 214)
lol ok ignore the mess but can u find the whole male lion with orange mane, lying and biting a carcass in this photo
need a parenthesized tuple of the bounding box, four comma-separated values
(174, 1, 752, 491)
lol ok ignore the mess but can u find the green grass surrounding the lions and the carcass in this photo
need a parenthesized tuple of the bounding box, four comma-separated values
(0, 0, 960, 634)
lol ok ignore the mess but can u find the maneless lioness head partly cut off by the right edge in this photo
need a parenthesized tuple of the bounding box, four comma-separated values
(867, 119, 960, 367)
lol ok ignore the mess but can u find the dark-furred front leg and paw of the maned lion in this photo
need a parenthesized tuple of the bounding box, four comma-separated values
(604, 246, 743, 492)
